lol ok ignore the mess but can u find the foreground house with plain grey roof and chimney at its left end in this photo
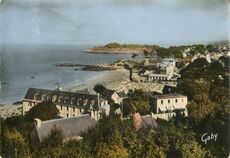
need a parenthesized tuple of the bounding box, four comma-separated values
(30, 114, 96, 147)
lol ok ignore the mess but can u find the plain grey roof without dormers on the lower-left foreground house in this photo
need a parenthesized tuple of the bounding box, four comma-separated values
(36, 115, 96, 142)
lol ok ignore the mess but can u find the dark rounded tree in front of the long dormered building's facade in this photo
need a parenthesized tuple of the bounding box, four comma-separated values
(25, 101, 59, 121)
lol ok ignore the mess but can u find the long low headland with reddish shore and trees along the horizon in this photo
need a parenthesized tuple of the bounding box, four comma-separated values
(85, 43, 224, 58)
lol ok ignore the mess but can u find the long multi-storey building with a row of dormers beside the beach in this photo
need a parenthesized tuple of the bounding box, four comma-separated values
(23, 88, 110, 120)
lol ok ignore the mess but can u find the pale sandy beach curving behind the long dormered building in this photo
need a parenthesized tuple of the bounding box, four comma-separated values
(0, 69, 164, 118)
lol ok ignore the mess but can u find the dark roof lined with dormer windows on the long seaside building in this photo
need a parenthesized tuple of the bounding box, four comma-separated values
(24, 88, 103, 109)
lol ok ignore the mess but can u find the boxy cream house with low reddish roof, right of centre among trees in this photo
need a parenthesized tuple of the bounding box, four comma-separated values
(151, 94, 187, 120)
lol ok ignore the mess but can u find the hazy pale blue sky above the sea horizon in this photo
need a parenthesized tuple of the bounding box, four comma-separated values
(0, 0, 230, 45)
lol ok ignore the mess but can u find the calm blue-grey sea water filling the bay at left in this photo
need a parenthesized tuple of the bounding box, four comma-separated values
(0, 45, 130, 104)
